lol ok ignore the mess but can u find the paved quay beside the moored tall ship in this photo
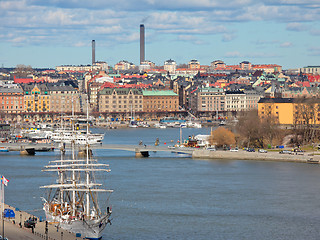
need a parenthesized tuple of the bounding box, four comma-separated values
(0, 204, 83, 240)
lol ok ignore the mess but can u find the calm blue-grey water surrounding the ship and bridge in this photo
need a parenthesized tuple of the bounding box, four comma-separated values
(0, 129, 320, 240)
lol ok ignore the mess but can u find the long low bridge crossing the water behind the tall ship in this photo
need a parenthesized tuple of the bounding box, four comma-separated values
(0, 143, 194, 157)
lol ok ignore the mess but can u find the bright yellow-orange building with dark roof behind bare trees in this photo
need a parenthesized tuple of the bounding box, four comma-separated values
(258, 98, 320, 125)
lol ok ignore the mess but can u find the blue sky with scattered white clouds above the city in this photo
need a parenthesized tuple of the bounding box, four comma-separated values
(0, 0, 320, 69)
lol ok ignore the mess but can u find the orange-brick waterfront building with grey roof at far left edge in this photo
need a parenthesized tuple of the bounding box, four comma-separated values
(0, 87, 24, 113)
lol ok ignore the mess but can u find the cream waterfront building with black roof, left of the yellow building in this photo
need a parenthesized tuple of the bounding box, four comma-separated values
(225, 90, 247, 112)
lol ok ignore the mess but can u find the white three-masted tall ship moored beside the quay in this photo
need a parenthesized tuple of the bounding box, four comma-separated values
(41, 116, 113, 239)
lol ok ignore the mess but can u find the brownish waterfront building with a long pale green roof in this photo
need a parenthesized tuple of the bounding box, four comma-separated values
(142, 90, 179, 112)
